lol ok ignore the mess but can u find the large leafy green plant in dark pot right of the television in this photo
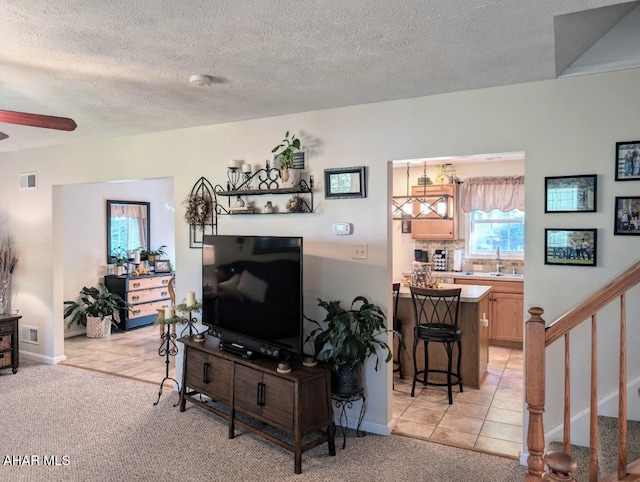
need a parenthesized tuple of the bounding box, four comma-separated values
(304, 296, 393, 395)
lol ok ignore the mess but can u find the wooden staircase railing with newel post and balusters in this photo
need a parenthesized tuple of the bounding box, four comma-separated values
(525, 261, 640, 482)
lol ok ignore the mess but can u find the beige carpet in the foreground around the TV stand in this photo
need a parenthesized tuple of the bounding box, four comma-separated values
(0, 362, 525, 482)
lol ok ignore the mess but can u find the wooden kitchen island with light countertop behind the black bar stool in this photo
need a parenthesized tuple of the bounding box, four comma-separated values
(398, 283, 491, 388)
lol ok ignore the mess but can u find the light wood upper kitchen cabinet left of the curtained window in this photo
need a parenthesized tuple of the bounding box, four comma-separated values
(411, 184, 458, 239)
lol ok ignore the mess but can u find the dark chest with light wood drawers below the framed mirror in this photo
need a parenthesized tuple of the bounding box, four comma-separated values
(104, 274, 173, 330)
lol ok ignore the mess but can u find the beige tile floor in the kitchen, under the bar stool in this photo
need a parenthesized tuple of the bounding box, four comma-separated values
(393, 347, 523, 458)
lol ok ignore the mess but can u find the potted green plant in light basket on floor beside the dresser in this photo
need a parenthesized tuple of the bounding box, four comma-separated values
(64, 283, 131, 338)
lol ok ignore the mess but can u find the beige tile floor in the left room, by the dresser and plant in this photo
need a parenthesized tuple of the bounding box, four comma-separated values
(62, 325, 176, 386)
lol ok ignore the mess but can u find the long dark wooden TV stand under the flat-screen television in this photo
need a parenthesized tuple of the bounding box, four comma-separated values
(178, 336, 336, 474)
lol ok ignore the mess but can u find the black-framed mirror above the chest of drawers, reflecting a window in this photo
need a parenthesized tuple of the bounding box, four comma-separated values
(107, 199, 151, 264)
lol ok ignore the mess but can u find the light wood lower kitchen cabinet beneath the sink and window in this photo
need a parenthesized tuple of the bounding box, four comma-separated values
(455, 278, 524, 348)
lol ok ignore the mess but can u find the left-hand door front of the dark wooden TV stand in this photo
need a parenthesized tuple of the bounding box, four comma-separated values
(184, 347, 233, 405)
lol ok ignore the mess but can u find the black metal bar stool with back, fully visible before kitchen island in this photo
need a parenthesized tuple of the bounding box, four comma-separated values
(410, 286, 462, 405)
